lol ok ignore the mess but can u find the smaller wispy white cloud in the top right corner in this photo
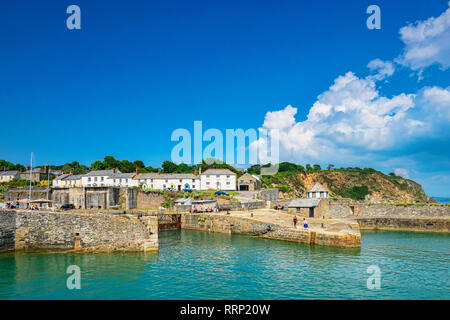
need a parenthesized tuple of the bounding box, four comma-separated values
(396, 2, 450, 72)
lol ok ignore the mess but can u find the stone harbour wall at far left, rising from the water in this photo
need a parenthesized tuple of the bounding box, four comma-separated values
(0, 211, 158, 252)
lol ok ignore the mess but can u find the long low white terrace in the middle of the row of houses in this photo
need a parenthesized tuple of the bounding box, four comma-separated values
(136, 173, 200, 191)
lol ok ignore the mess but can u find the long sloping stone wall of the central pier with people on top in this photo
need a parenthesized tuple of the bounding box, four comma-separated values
(181, 213, 361, 248)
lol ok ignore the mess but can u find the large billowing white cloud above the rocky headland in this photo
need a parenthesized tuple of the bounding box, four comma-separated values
(261, 72, 450, 165)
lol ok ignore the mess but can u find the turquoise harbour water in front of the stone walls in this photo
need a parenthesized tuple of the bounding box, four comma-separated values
(0, 230, 450, 299)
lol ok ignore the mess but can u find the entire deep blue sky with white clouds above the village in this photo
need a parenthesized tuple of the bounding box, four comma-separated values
(0, 0, 450, 196)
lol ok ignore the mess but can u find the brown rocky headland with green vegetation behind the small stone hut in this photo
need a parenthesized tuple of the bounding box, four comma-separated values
(276, 170, 435, 203)
